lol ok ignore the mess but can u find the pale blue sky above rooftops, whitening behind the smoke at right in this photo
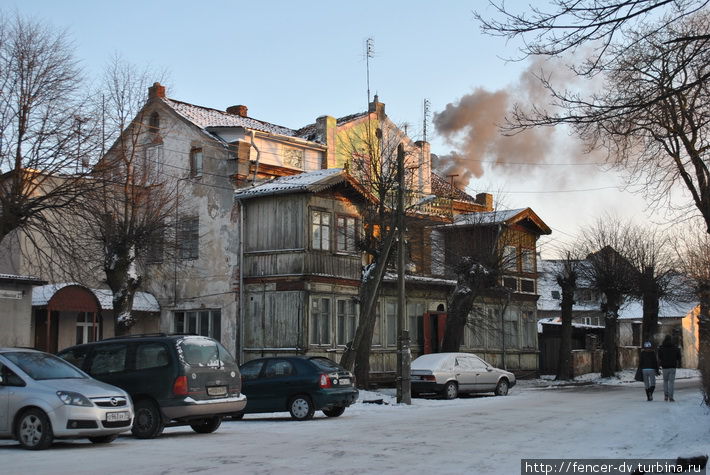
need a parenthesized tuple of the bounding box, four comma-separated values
(11, 0, 663, 255)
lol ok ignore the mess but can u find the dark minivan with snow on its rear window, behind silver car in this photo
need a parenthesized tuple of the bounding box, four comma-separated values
(59, 334, 246, 439)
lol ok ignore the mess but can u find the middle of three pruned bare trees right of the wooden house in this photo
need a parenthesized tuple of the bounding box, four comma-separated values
(580, 216, 636, 378)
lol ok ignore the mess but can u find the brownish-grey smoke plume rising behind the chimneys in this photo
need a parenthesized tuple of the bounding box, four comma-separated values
(433, 59, 567, 188)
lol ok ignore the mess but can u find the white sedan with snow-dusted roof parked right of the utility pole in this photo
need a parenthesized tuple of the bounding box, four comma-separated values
(411, 353, 515, 399)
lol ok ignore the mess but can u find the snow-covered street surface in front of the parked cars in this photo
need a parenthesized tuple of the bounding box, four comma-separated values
(0, 378, 710, 475)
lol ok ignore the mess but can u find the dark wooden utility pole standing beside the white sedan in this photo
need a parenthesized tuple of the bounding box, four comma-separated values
(397, 143, 412, 404)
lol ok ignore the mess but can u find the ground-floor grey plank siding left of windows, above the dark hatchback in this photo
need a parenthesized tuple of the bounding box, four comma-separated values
(244, 291, 306, 350)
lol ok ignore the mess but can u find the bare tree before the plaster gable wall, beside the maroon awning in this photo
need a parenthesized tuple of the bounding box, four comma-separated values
(74, 57, 178, 335)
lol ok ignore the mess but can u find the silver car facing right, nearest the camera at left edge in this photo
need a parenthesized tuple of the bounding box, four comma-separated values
(0, 348, 133, 450)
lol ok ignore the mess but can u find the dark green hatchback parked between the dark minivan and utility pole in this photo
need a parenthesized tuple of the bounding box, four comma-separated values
(233, 356, 358, 421)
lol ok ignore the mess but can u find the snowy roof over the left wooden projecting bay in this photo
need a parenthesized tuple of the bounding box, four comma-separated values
(234, 168, 346, 199)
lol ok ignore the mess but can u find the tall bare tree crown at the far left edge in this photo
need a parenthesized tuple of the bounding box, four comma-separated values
(0, 15, 97, 249)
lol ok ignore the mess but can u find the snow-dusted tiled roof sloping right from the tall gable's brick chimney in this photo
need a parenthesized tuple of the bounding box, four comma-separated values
(163, 98, 296, 137)
